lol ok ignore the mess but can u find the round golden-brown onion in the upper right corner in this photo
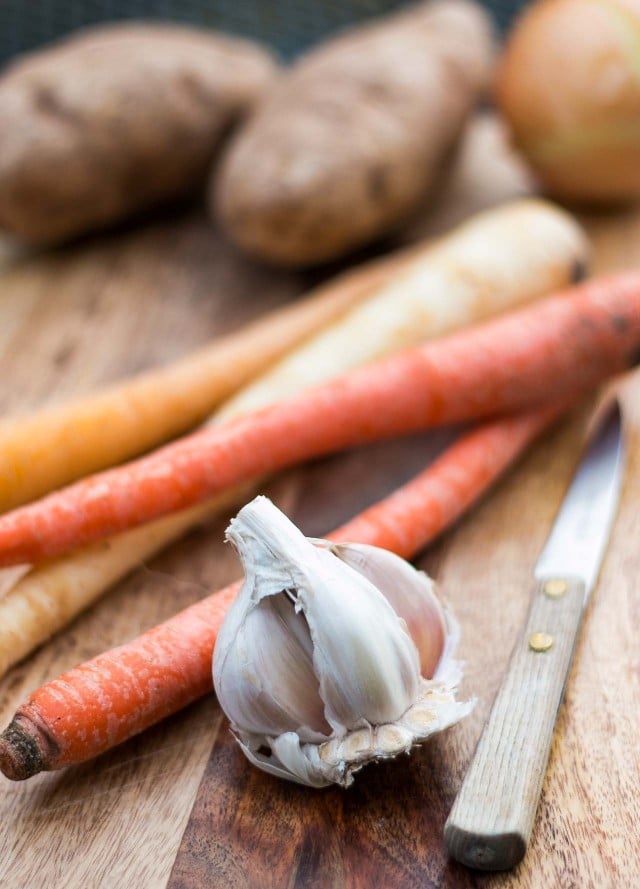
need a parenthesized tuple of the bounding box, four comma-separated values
(496, 0, 640, 204)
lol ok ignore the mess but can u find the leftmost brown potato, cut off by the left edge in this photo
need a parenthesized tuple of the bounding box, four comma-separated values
(0, 23, 277, 244)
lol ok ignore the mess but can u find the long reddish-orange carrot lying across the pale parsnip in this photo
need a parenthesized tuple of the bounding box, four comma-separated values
(0, 271, 640, 566)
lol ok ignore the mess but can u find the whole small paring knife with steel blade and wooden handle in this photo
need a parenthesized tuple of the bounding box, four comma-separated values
(444, 398, 624, 870)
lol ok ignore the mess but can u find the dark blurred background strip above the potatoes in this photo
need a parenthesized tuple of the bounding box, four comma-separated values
(0, 0, 525, 63)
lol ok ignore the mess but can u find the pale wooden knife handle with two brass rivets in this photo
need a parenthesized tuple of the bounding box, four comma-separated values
(444, 578, 585, 870)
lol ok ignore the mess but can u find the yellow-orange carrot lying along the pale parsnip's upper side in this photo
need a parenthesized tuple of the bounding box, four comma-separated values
(0, 254, 400, 512)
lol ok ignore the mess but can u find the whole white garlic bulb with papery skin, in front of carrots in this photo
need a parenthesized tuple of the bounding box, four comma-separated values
(213, 497, 473, 787)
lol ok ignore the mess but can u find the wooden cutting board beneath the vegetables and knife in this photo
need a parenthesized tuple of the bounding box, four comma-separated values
(0, 119, 640, 889)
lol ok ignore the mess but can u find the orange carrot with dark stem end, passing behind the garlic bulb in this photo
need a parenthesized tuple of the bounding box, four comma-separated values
(0, 407, 560, 780)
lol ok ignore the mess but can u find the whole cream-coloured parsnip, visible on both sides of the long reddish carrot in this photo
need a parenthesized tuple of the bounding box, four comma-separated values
(0, 201, 587, 674)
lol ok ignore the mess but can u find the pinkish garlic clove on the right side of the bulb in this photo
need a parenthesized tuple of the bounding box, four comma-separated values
(322, 543, 447, 679)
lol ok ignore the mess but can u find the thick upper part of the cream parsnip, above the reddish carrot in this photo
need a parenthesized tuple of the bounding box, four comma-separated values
(215, 200, 587, 422)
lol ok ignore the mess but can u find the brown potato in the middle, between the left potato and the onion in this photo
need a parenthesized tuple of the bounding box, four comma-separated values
(215, 0, 493, 266)
